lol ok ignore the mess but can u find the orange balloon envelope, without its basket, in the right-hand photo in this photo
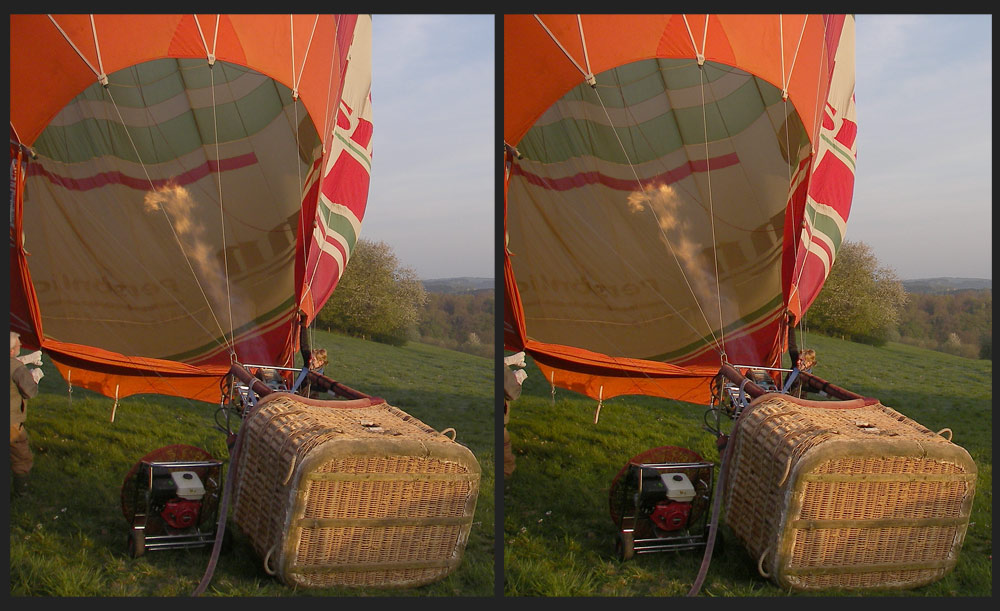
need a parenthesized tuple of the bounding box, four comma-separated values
(503, 15, 856, 403)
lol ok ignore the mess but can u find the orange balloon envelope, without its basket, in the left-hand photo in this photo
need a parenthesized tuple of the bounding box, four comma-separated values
(10, 15, 372, 401)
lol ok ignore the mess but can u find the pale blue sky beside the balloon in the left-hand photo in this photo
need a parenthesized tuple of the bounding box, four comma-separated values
(361, 14, 497, 280)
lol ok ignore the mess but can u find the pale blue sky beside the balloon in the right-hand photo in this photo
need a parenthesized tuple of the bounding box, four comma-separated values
(847, 15, 993, 280)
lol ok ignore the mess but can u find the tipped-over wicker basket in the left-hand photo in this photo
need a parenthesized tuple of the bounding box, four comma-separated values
(233, 393, 480, 587)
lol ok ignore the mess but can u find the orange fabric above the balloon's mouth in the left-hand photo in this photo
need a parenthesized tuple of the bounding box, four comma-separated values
(10, 15, 353, 146)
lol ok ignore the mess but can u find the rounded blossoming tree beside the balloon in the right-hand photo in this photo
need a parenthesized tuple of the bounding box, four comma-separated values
(808, 241, 907, 346)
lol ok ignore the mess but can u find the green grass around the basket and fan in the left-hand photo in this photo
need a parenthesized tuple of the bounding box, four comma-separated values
(10, 332, 495, 597)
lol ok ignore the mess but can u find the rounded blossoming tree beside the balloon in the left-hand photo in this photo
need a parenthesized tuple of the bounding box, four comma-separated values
(317, 239, 427, 346)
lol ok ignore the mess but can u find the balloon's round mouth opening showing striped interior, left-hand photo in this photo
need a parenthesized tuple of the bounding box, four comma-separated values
(23, 59, 322, 364)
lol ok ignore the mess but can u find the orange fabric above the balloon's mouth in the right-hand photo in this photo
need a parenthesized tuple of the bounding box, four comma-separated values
(503, 15, 830, 146)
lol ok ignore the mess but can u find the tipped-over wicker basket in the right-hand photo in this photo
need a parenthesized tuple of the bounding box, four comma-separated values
(724, 394, 976, 590)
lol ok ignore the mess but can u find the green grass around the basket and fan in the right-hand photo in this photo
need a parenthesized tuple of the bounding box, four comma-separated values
(503, 335, 993, 597)
